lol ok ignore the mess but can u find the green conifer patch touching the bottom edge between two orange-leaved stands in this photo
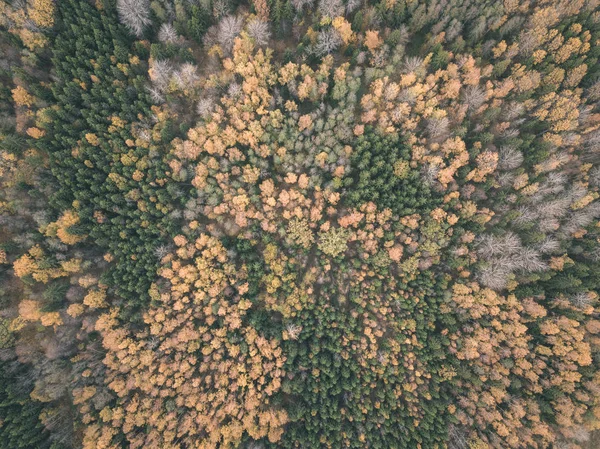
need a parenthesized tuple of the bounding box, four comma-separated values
(276, 273, 448, 449)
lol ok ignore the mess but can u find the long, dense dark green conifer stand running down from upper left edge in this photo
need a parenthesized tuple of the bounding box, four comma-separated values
(40, 1, 176, 307)
